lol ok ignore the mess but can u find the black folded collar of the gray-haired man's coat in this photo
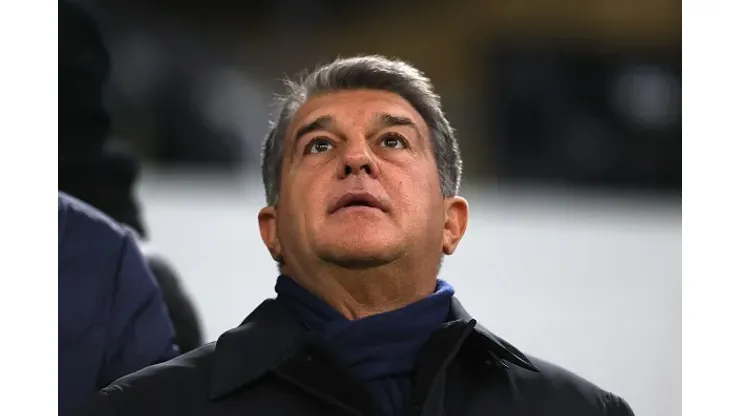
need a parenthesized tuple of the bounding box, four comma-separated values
(209, 297, 539, 400)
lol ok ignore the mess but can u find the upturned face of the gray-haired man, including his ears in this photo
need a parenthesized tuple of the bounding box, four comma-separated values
(260, 90, 467, 268)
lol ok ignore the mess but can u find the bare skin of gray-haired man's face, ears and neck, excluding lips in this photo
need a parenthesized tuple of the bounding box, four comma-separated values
(258, 90, 468, 319)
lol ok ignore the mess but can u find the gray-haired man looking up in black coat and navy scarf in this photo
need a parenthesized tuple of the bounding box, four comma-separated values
(81, 56, 632, 416)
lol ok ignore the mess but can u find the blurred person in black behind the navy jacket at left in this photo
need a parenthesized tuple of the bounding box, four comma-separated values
(58, 1, 203, 352)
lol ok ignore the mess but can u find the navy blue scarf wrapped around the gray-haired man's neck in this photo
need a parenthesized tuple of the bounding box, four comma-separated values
(275, 276, 455, 415)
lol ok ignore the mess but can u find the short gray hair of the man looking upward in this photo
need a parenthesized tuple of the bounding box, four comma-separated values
(262, 56, 462, 206)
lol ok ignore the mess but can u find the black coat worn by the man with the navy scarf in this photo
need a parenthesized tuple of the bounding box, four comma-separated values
(84, 298, 633, 416)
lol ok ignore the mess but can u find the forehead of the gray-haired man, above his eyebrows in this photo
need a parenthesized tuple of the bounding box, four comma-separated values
(288, 90, 428, 137)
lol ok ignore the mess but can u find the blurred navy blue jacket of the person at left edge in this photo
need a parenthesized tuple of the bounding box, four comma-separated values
(58, 193, 176, 414)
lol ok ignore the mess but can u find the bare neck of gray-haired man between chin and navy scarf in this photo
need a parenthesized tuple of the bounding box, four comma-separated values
(283, 265, 437, 320)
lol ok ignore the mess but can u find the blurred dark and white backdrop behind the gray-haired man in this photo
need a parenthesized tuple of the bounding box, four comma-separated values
(71, 0, 681, 415)
